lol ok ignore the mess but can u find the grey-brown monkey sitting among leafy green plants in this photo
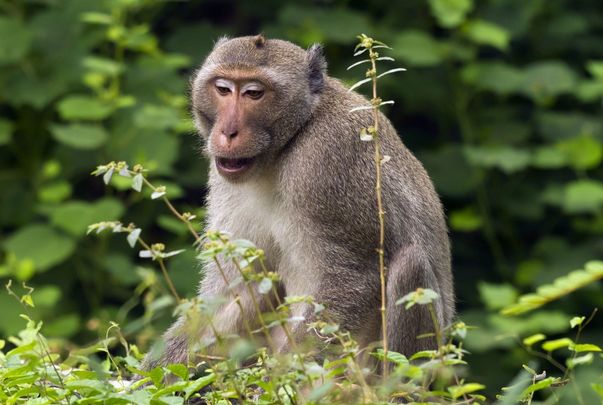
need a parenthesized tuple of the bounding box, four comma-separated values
(145, 35, 455, 369)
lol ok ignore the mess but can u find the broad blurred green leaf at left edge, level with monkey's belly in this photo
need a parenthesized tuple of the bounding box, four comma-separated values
(4, 224, 75, 271)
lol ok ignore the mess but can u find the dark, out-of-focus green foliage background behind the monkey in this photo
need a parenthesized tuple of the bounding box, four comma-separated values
(0, 0, 603, 403)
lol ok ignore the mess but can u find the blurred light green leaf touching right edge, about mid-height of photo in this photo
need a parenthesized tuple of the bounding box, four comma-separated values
(563, 180, 603, 214)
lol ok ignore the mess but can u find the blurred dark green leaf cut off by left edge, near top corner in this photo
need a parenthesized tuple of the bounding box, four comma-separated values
(0, 16, 32, 66)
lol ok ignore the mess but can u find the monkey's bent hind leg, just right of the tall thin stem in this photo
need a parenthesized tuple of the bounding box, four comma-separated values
(386, 245, 450, 356)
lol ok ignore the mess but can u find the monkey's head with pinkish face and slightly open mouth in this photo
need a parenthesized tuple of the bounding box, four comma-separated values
(192, 35, 326, 181)
